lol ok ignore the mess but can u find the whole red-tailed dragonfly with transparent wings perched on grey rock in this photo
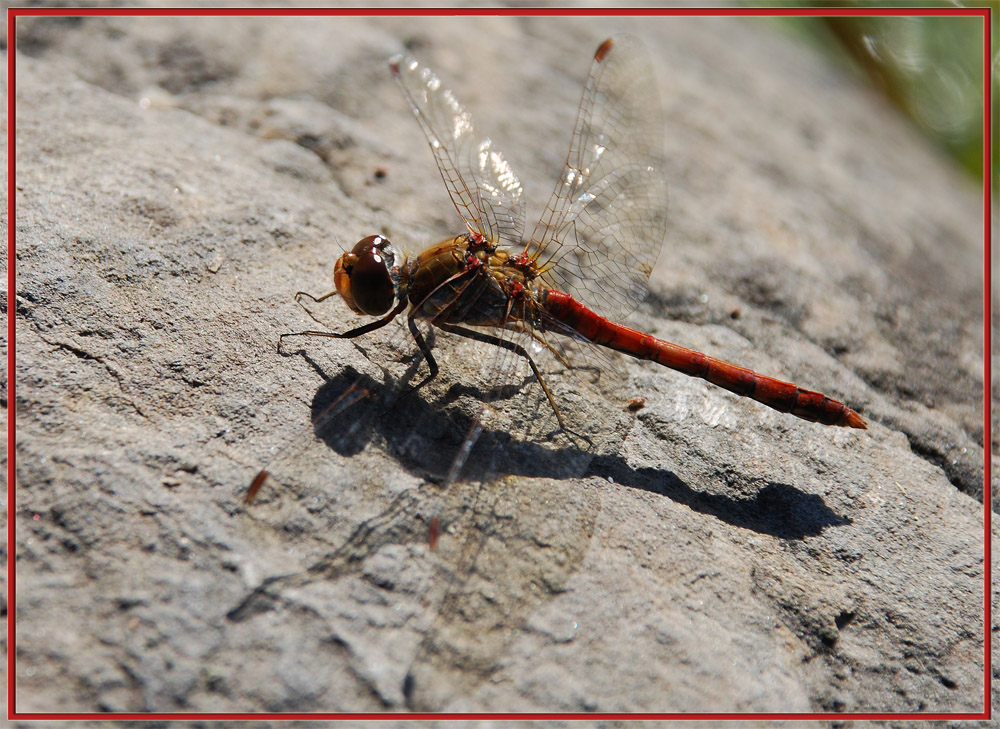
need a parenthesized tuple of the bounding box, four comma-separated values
(255, 35, 867, 500)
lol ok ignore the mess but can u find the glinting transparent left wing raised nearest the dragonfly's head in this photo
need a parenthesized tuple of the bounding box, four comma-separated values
(389, 56, 524, 245)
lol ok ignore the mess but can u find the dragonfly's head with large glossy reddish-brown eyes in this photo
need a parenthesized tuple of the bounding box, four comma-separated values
(333, 235, 399, 316)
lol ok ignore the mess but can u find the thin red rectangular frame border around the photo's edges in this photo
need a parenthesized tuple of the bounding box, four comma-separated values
(7, 7, 993, 721)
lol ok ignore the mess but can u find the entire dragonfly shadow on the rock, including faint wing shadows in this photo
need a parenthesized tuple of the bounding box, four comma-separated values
(229, 352, 849, 710)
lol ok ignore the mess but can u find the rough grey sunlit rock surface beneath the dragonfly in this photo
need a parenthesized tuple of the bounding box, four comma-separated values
(14, 9, 984, 712)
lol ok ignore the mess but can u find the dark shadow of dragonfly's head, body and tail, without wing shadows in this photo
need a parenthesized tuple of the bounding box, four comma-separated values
(300, 356, 851, 539)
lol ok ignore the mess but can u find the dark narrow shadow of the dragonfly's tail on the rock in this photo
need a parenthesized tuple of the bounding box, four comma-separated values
(587, 456, 852, 539)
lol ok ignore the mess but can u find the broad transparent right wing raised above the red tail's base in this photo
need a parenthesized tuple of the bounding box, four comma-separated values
(525, 35, 667, 318)
